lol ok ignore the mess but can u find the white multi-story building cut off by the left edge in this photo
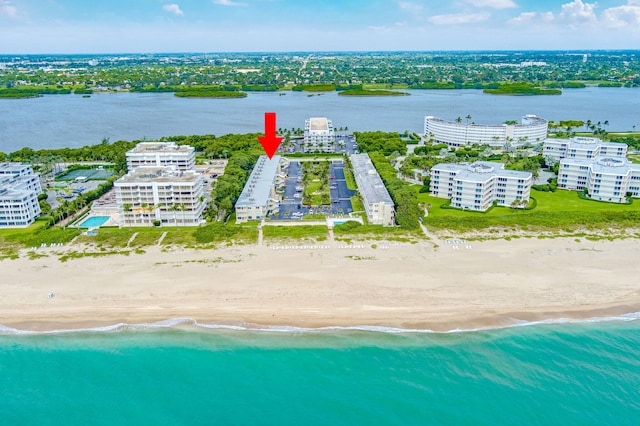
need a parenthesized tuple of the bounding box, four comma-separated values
(0, 163, 42, 228)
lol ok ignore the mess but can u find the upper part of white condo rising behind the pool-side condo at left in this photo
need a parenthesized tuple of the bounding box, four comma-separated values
(127, 142, 196, 171)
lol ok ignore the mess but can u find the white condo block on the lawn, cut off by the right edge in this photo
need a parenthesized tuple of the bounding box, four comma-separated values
(558, 157, 640, 203)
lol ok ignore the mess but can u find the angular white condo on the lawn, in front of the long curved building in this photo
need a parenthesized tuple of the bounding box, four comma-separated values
(429, 161, 533, 211)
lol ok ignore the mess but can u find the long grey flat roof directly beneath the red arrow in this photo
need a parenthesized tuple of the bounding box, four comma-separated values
(236, 155, 281, 207)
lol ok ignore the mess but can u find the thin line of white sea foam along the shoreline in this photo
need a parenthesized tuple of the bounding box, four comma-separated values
(0, 312, 640, 335)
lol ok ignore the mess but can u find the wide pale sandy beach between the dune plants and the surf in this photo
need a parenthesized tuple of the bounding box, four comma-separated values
(0, 238, 640, 331)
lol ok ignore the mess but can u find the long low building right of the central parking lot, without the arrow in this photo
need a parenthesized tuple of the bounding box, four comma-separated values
(349, 154, 395, 226)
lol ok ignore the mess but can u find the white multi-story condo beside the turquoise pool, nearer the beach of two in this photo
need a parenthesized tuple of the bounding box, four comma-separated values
(114, 166, 206, 226)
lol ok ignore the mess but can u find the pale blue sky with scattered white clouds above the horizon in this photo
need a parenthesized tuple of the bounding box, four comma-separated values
(0, 0, 640, 53)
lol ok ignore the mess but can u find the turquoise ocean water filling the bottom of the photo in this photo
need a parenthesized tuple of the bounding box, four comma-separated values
(0, 314, 640, 425)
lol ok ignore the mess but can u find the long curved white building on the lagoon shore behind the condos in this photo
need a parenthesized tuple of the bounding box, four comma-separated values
(424, 115, 549, 148)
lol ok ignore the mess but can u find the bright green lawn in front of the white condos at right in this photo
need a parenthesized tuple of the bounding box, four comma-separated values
(414, 185, 640, 231)
